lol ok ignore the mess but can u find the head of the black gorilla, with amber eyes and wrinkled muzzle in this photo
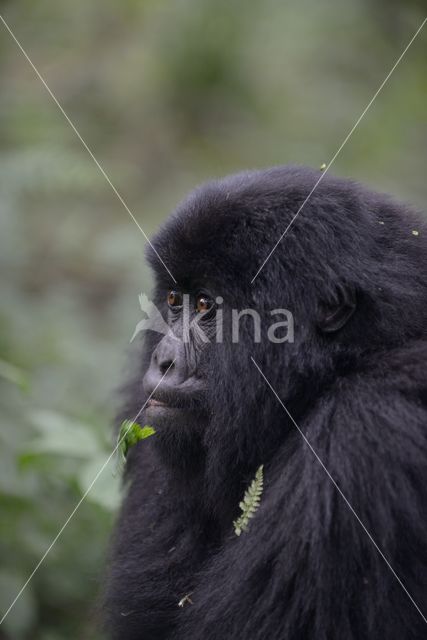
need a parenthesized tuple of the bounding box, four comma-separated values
(140, 168, 426, 496)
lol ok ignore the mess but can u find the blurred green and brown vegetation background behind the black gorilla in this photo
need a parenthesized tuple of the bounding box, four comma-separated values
(0, 0, 427, 640)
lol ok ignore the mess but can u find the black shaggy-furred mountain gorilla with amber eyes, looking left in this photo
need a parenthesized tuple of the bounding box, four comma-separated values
(105, 167, 427, 640)
